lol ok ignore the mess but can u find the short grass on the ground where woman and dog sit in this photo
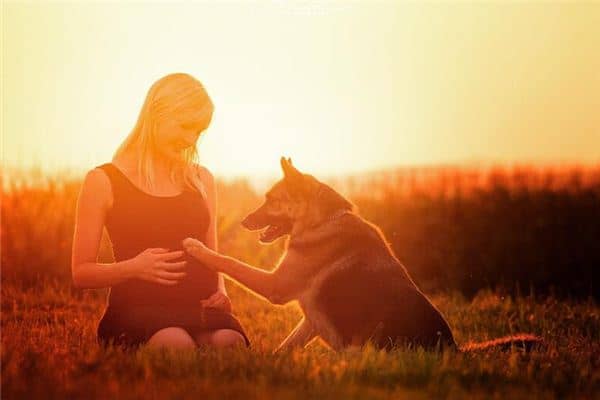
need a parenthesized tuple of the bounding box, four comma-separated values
(2, 282, 600, 399)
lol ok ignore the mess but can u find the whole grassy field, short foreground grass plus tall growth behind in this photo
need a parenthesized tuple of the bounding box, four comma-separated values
(0, 166, 600, 399)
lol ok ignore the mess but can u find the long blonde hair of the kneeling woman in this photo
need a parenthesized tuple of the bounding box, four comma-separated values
(113, 73, 214, 198)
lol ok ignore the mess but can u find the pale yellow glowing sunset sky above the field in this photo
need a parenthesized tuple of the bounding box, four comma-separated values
(2, 0, 600, 180)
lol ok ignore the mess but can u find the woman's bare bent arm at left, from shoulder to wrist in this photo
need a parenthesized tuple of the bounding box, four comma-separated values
(71, 168, 134, 289)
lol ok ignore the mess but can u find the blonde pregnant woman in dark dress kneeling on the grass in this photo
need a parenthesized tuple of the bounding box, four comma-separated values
(71, 73, 250, 348)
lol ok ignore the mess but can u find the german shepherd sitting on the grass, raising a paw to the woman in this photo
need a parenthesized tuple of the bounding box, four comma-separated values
(183, 157, 538, 351)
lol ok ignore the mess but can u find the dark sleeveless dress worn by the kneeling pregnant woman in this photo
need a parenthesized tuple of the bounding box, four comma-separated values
(97, 163, 250, 348)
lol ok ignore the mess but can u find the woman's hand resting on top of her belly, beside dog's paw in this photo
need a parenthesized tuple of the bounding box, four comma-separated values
(131, 248, 187, 286)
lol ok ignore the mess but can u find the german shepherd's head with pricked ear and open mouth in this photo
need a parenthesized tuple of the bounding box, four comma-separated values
(242, 157, 354, 243)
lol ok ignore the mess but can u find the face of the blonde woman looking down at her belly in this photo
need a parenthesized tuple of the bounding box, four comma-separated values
(156, 110, 212, 158)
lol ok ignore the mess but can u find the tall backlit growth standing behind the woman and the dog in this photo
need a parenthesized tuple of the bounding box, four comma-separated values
(2, 162, 600, 299)
